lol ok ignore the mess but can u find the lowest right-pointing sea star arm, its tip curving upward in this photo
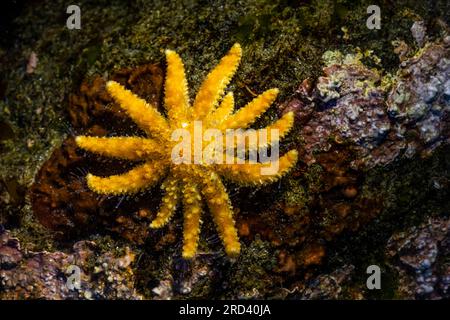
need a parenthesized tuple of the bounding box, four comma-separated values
(216, 150, 298, 185)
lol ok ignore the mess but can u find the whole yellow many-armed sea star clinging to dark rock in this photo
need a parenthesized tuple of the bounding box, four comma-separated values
(76, 44, 297, 259)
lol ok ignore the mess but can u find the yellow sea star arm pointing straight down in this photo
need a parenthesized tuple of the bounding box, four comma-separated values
(183, 180, 202, 259)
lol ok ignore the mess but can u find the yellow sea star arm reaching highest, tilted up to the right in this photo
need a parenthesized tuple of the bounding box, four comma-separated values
(193, 43, 242, 120)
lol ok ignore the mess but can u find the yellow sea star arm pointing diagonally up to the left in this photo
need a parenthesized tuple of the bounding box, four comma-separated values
(106, 81, 169, 136)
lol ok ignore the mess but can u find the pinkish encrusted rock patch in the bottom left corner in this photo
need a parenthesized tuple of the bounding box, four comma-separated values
(0, 229, 142, 300)
